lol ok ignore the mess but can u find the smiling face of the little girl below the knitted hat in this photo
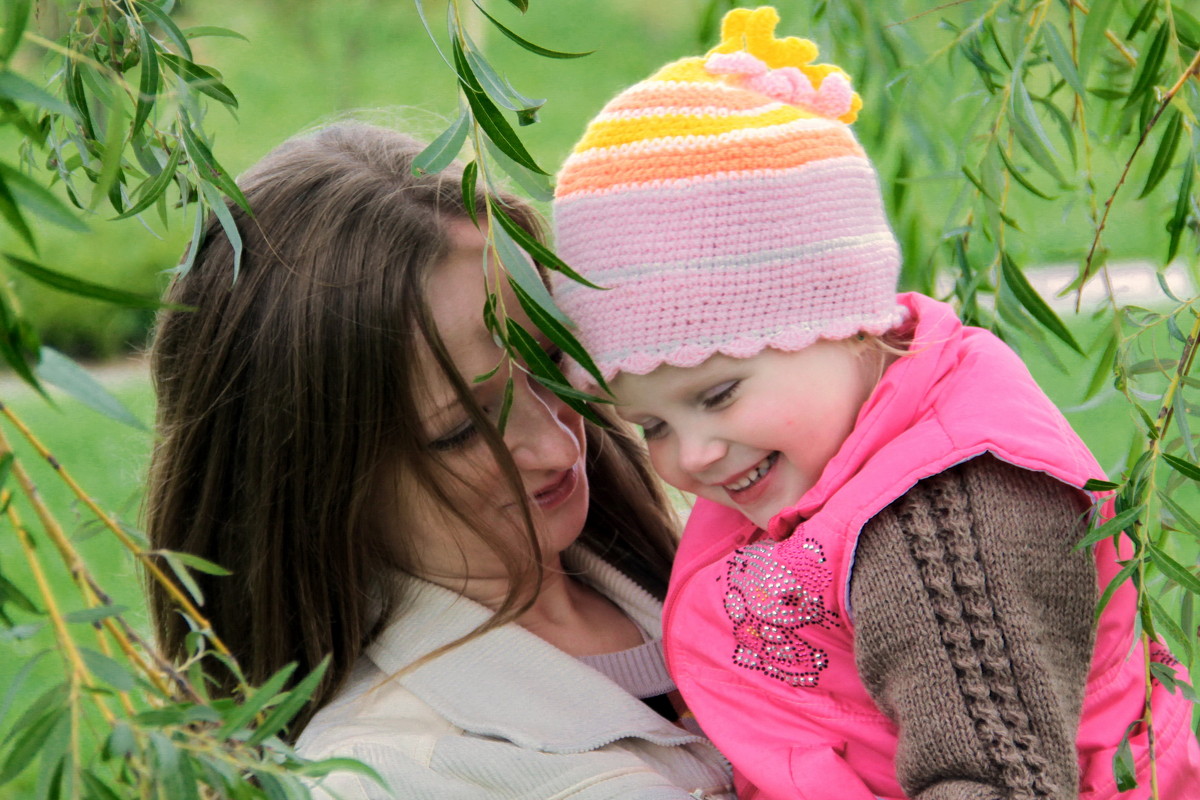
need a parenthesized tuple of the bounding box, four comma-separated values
(611, 341, 881, 528)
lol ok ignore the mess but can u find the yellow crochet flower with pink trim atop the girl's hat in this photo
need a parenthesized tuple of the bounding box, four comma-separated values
(704, 6, 863, 124)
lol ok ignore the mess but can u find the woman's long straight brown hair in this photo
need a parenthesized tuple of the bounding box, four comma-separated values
(146, 125, 674, 736)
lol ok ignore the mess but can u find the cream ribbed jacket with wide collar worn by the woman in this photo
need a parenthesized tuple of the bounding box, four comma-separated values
(296, 547, 733, 800)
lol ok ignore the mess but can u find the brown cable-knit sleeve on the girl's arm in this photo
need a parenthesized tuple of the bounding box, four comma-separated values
(851, 456, 1097, 800)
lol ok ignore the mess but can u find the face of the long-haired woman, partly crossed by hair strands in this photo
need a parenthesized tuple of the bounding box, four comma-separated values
(394, 221, 588, 588)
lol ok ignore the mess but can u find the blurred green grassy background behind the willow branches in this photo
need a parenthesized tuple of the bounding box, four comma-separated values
(0, 0, 1195, 796)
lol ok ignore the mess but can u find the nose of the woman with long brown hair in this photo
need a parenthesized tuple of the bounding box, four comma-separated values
(504, 373, 581, 471)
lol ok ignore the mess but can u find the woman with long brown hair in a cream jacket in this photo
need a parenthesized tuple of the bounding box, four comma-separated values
(148, 125, 732, 799)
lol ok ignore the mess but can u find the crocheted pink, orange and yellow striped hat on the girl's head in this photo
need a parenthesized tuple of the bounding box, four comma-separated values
(552, 7, 904, 385)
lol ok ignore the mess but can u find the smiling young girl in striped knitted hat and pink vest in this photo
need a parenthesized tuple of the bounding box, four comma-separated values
(556, 8, 1200, 800)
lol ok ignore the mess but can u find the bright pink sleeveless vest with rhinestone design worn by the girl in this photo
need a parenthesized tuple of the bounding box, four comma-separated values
(664, 294, 1200, 800)
